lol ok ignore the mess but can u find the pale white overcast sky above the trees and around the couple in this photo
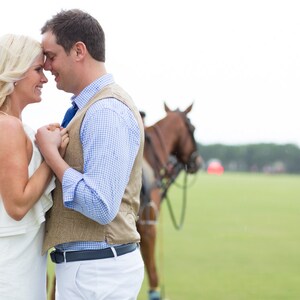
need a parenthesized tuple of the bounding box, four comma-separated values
(0, 0, 300, 146)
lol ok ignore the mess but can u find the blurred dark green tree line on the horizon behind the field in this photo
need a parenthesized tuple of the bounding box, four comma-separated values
(197, 143, 300, 174)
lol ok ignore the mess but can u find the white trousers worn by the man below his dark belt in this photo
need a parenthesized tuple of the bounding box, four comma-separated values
(55, 248, 144, 300)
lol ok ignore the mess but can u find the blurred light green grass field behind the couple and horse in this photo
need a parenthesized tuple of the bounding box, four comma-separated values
(47, 173, 300, 300)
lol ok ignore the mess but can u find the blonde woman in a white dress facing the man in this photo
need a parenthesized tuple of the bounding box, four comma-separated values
(0, 34, 68, 300)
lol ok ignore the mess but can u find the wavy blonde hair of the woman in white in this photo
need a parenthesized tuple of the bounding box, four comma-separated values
(0, 34, 43, 107)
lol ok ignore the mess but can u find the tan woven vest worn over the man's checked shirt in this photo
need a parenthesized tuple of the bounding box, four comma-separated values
(43, 84, 144, 253)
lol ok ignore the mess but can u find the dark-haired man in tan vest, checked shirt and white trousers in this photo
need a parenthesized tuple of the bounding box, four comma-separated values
(36, 9, 144, 300)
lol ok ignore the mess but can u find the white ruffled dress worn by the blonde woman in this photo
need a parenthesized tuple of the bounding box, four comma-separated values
(0, 125, 55, 300)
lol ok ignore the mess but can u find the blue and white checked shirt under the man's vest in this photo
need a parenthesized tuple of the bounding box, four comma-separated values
(56, 74, 140, 251)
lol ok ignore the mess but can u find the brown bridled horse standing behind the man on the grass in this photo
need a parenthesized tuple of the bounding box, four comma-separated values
(137, 103, 202, 300)
